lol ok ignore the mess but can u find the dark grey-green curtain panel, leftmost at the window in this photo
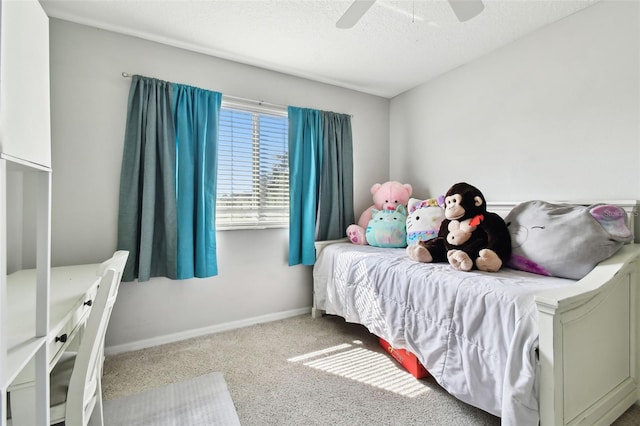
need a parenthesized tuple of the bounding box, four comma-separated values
(118, 75, 177, 281)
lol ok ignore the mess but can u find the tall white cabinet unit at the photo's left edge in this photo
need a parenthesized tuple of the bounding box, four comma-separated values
(0, 0, 51, 426)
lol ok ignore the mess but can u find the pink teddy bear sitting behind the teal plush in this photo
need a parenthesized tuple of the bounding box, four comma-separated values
(347, 181, 413, 245)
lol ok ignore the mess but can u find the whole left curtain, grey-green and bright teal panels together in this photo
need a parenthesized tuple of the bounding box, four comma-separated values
(118, 75, 222, 281)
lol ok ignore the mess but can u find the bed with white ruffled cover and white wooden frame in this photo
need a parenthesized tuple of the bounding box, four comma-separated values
(312, 201, 640, 426)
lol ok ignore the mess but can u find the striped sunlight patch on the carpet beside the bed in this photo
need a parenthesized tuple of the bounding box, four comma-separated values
(288, 341, 430, 398)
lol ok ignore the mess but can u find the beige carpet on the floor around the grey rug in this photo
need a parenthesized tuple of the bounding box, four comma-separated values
(103, 315, 640, 426)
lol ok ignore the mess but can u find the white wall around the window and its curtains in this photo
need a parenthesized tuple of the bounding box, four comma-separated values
(51, 19, 389, 349)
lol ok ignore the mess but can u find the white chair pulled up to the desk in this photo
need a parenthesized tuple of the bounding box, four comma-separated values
(50, 251, 129, 426)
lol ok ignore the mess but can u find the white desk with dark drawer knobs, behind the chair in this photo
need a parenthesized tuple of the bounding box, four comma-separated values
(7, 264, 100, 426)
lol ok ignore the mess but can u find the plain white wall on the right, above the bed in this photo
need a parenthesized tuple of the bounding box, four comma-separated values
(390, 1, 640, 201)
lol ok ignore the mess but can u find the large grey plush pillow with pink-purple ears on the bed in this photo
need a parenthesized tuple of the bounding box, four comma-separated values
(505, 200, 633, 280)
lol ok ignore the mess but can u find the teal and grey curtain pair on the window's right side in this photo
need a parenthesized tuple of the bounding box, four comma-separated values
(288, 107, 354, 266)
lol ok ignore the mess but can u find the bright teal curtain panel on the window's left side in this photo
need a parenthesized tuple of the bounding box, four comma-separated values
(173, 84, 222, 279)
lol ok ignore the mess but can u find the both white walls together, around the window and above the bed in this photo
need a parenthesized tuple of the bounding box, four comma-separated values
(50, 1, 640, 348)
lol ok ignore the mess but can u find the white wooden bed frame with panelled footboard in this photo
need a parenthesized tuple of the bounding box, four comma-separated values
(312, 200, 640, 426)
